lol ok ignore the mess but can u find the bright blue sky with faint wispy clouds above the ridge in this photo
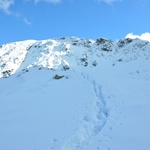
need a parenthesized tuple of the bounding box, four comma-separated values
(0, 0, 150, 45)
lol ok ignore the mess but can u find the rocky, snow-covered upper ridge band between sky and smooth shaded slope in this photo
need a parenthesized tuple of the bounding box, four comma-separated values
(0, 37, 150, 78)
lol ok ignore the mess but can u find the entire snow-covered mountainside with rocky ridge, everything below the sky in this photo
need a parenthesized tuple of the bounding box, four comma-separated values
(0, 37, 150, 150)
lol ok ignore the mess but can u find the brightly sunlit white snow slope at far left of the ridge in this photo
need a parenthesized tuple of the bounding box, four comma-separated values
(0, 40, 36, 77)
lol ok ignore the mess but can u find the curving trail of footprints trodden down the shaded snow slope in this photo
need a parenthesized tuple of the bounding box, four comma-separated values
(63, 73, 109, 150)
